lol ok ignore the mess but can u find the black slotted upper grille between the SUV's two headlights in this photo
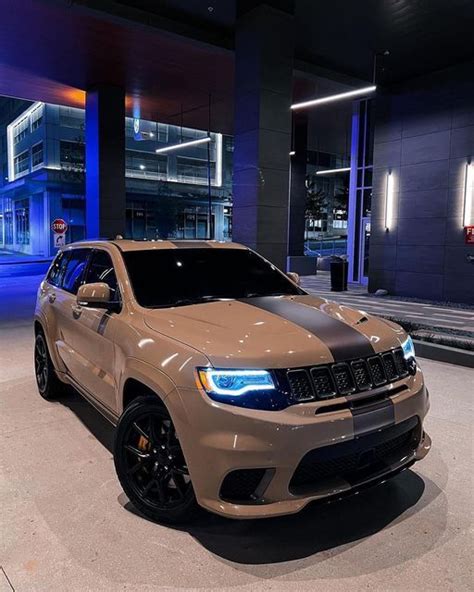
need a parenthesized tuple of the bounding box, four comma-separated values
(287, 348, 408, 403)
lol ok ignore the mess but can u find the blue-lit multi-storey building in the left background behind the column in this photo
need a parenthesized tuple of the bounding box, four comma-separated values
(0, 99, 233, 256)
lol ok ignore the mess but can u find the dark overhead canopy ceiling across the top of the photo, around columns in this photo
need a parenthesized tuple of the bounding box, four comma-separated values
(0, 0, 474, 133)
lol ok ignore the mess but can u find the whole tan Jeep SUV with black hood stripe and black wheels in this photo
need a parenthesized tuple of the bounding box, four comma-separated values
(35, 240, 430, 522)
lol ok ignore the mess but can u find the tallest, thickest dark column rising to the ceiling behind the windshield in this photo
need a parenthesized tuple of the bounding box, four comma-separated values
(232, 2, 294, 269)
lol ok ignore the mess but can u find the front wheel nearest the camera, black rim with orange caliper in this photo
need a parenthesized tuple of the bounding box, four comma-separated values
(114, 396, 198, 524)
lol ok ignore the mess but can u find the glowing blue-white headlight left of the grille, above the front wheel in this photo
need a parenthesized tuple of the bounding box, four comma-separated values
(197, 368, 275, 397)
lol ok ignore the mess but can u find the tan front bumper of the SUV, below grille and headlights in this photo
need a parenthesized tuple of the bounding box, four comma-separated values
(166, 371, 431, 518)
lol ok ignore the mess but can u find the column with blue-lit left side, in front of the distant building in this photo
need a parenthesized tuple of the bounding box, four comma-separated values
(86, 86, 125, 238)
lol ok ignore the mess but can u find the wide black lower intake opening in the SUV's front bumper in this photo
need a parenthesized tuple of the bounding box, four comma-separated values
(289, 417, 421, 495)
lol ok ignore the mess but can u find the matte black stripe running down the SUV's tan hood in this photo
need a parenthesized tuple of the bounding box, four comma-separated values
(240, 296, 375, 362)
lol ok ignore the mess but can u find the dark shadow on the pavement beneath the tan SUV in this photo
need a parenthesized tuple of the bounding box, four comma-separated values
(62, 391, 425, 565)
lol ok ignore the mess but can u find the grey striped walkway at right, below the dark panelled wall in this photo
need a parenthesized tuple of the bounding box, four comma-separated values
(301, 271, 474, 337)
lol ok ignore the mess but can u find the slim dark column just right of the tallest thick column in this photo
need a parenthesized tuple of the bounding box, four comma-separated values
(288, 113, 308, 257)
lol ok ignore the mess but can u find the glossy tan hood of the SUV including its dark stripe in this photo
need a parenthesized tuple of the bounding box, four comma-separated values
(144, 295, 405, 368)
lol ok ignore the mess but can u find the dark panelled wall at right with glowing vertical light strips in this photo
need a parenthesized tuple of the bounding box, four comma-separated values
(369, 62, 474, 304)
